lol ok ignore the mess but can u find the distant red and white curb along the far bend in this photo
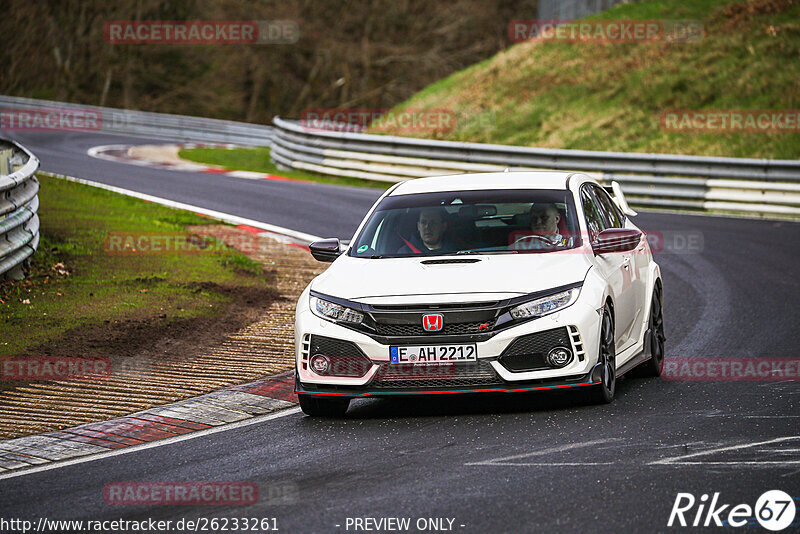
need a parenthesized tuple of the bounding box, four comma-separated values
(86, 143, 304, 182)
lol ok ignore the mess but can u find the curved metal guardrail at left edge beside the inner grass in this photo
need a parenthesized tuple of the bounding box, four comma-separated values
(0, 140, 39, 280)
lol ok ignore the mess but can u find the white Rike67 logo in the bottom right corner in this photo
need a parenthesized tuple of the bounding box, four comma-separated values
(667, 490, 796, 532)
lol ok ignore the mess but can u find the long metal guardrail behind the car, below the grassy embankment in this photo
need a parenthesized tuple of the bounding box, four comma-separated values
(272, 117, 800, 216)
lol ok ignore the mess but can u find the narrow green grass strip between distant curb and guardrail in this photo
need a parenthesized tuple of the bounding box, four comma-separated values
(178, 147, 392, 189)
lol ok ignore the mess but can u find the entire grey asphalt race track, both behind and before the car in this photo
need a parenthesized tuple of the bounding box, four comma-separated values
(0, 133, 800, 533)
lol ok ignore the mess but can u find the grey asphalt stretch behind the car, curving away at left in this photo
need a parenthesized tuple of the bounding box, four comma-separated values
(7, 132, 381, 238)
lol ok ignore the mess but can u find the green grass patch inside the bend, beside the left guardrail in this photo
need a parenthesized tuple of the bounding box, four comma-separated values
(0, 174, 269, 356)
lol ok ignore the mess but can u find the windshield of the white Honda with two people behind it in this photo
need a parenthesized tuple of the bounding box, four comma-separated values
(349, 189, 580, 258)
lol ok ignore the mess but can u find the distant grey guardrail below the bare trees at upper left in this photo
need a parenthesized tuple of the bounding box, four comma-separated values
(0, 95, 274, 146)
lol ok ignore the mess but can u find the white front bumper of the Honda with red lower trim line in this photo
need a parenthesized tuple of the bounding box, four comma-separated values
(295, 293, 600, 397)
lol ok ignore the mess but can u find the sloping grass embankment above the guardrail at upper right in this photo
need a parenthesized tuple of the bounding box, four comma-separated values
(376, 0, 800, 159)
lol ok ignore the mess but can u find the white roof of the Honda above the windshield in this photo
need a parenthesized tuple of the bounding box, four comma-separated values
(390, 171, 589, 196)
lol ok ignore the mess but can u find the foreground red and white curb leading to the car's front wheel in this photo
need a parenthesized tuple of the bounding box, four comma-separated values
(0, 371, 297, 476)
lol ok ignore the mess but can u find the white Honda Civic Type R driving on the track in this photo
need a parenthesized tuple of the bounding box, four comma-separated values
(295, 172, 664, 416)
